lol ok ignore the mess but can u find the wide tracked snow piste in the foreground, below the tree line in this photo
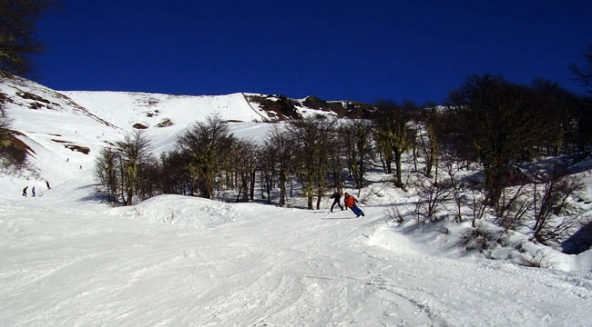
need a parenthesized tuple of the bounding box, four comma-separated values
(0, 193, 592, 327)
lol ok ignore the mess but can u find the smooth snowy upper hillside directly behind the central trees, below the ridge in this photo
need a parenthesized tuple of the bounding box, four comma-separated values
(63, 92, 286, 153)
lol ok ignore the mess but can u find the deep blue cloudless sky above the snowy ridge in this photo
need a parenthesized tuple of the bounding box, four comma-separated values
(35, 0, 592, 103)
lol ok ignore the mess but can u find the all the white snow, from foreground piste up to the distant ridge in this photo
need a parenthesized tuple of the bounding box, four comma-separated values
(0, 75, 592, 327)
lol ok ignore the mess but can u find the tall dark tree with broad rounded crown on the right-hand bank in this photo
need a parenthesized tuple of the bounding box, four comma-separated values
(448, 75, 545, 206)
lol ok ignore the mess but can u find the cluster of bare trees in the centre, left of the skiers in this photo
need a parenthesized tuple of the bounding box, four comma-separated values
(96, 116, 380, 209)
